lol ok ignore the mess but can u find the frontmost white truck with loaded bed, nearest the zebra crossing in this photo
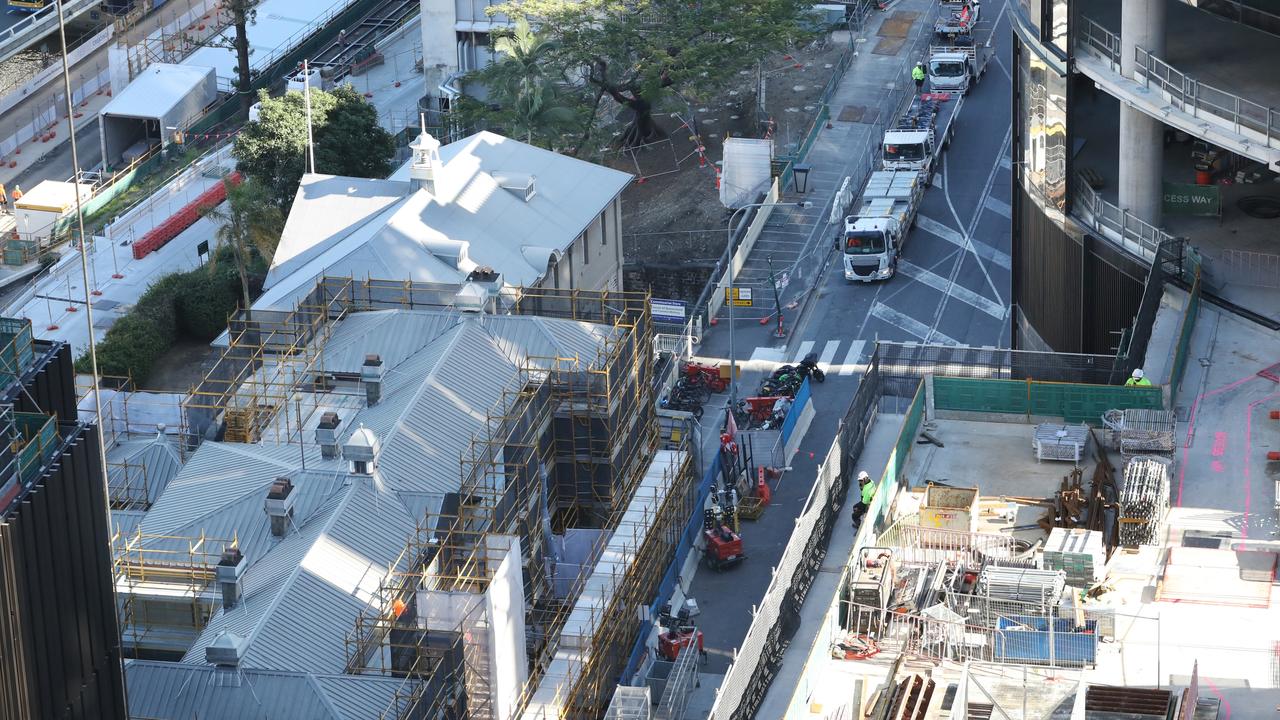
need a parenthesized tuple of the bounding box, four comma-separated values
(841, 170, 924, 282)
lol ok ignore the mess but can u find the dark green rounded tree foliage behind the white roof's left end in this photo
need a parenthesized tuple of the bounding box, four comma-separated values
(232, 85, 396, 208)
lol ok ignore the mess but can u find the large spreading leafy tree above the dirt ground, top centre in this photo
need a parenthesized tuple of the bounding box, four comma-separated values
(490, 0, 810, 146)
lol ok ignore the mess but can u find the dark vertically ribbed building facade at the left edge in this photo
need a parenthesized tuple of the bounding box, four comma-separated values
(0, 319, 125, 720)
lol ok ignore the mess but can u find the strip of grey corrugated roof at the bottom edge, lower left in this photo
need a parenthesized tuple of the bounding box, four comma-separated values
(124, 660, 403, 720)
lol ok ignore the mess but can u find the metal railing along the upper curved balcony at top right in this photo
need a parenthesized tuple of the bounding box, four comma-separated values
(1076, 17, 1280, 147)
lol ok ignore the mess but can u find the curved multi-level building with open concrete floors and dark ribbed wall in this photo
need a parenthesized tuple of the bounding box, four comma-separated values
(1009, 0, 1280, 354)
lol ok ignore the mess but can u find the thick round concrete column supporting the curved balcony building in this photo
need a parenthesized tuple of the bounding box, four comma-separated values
(1117, 0, 1166, 225)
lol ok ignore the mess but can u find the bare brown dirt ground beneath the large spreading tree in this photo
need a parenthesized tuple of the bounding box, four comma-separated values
(608, 32, 849, 270)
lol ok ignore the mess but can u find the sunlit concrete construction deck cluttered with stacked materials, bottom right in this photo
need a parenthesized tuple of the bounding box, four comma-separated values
(710, 322, 1280, 720)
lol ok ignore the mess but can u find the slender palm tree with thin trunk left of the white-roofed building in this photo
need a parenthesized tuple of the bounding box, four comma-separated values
(201, 178, 284, 320)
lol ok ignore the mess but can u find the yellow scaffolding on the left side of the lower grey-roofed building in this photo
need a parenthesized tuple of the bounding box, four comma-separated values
(111, 530, 239, 657)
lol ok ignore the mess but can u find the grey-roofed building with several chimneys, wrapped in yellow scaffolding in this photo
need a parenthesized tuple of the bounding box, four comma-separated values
(104, 278, 696, 717)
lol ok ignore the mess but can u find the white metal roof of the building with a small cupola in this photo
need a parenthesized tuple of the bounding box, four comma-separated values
(255, 132, 631, 307)
